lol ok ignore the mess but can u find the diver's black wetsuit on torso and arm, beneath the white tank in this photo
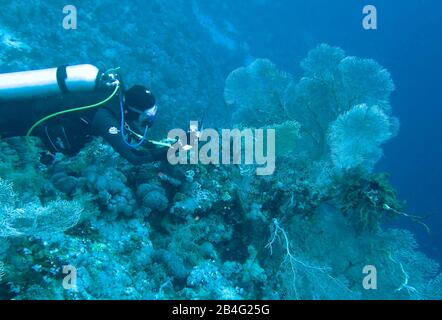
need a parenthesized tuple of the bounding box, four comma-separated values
(0, 91, 160, 165)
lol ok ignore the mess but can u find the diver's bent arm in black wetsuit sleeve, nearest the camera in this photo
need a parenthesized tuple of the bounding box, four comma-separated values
(92, 108, 155, 165)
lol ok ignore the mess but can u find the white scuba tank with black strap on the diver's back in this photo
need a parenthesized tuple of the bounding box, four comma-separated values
(0, 64, 101, 100)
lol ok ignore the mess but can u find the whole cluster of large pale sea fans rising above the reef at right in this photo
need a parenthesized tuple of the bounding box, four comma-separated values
(224, 44, 398, 171)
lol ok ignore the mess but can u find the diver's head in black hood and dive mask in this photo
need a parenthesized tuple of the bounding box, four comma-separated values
(124, 85, 158, 127)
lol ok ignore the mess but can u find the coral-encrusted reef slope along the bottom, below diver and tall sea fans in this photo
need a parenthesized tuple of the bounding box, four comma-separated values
(0, 132, 440, 299)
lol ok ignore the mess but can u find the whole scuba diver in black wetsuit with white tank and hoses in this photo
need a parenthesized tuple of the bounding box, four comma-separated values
(0, 65, 166, 165)
